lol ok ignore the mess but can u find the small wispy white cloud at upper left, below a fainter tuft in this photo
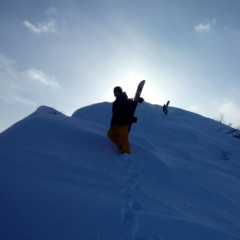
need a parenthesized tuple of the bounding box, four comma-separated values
(23, 19, 57, 34)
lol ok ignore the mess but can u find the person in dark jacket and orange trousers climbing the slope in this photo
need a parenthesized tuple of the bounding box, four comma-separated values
(107, 86, 135, 154)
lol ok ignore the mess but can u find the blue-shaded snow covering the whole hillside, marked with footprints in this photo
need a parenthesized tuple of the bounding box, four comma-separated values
(0, 102, 240, 240)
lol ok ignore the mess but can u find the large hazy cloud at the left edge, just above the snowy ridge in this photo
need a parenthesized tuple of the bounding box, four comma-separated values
(0, 54, 60, 105)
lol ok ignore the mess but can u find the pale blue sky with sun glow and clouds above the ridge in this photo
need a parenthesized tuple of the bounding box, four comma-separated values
(0, 0, 240, 132)
